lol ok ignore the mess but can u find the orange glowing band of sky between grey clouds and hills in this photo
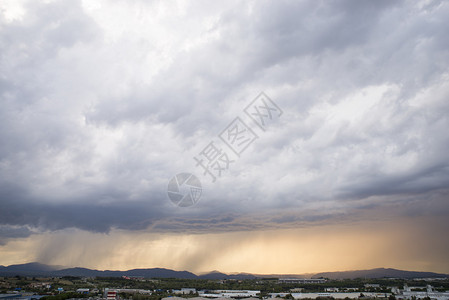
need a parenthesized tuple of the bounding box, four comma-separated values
(0, 219, 449, 274)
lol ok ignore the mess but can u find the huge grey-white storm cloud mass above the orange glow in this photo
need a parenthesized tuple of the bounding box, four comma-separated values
(0, 1, 449, 238)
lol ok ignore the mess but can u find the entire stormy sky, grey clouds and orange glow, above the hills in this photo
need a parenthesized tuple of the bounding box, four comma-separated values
(0, 0, 449, 273)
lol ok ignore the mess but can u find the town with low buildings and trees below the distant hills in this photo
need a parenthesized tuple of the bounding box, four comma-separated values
(0, 273, 449, 300)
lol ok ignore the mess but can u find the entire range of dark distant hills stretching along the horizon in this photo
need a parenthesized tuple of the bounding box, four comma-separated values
(0, 263, 449, 280)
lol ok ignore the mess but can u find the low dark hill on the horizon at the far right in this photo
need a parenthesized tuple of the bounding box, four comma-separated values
(312, 268, 449, 279)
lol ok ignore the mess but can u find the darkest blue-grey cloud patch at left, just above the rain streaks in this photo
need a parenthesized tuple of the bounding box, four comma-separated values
(0, 180, 161, 233)
